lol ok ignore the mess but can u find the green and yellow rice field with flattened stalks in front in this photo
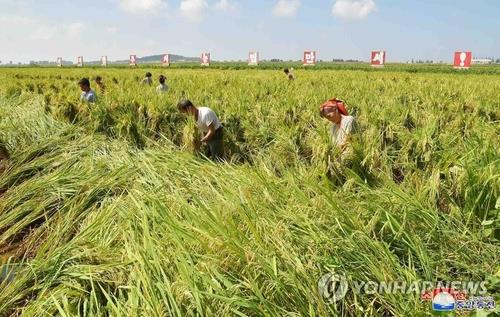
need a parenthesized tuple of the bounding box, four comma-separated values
(0, 68, 500, 316)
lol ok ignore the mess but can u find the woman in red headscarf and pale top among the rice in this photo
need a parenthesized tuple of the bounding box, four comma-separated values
(319, 98, 354, 151)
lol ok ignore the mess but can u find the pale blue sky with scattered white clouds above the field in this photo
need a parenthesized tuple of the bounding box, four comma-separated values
(0, 0, 500, 63)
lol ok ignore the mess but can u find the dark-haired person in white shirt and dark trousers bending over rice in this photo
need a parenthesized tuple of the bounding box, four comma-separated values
(177, 100, 224, 161)
